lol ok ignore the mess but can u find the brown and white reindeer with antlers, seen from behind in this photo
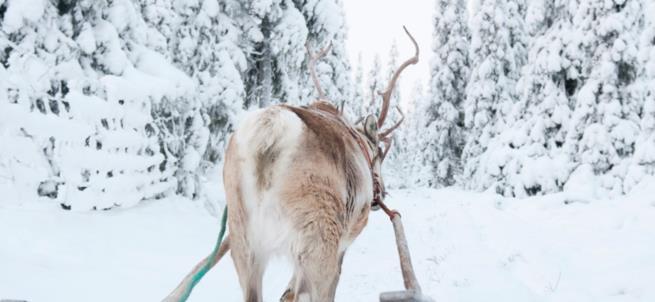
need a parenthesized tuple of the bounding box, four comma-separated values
(169, 29, 419, 302)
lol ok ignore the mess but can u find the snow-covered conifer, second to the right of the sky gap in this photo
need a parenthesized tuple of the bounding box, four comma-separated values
(462, 0, 526, 190)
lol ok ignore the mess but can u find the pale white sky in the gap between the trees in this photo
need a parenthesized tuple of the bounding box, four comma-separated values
(343, 0, 435, 107)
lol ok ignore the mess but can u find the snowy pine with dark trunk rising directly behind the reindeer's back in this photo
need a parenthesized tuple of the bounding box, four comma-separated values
(241, 0, 308, 107)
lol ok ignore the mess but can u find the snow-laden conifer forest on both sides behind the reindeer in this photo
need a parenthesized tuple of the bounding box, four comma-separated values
(0, 0, 655, 209)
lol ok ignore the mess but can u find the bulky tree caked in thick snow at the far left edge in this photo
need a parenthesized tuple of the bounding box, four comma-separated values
(0, 1, 183, 210)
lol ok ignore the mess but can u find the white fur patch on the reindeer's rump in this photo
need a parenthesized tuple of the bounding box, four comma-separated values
(235, 107, 304, 261)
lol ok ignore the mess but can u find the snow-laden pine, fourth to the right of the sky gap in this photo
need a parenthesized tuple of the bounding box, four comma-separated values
(564, 1, 644, 195)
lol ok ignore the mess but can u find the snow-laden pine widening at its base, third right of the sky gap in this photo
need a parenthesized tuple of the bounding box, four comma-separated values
(495, 1, 579, 196)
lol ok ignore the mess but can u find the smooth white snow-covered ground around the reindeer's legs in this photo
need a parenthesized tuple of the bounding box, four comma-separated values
(0, 187, 655, 302)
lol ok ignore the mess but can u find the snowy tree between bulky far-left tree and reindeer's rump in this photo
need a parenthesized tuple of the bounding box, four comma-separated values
(142, 0, 246, 197)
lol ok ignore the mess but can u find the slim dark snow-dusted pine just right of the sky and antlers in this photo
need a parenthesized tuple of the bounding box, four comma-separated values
(419, 0, 469, 186)
